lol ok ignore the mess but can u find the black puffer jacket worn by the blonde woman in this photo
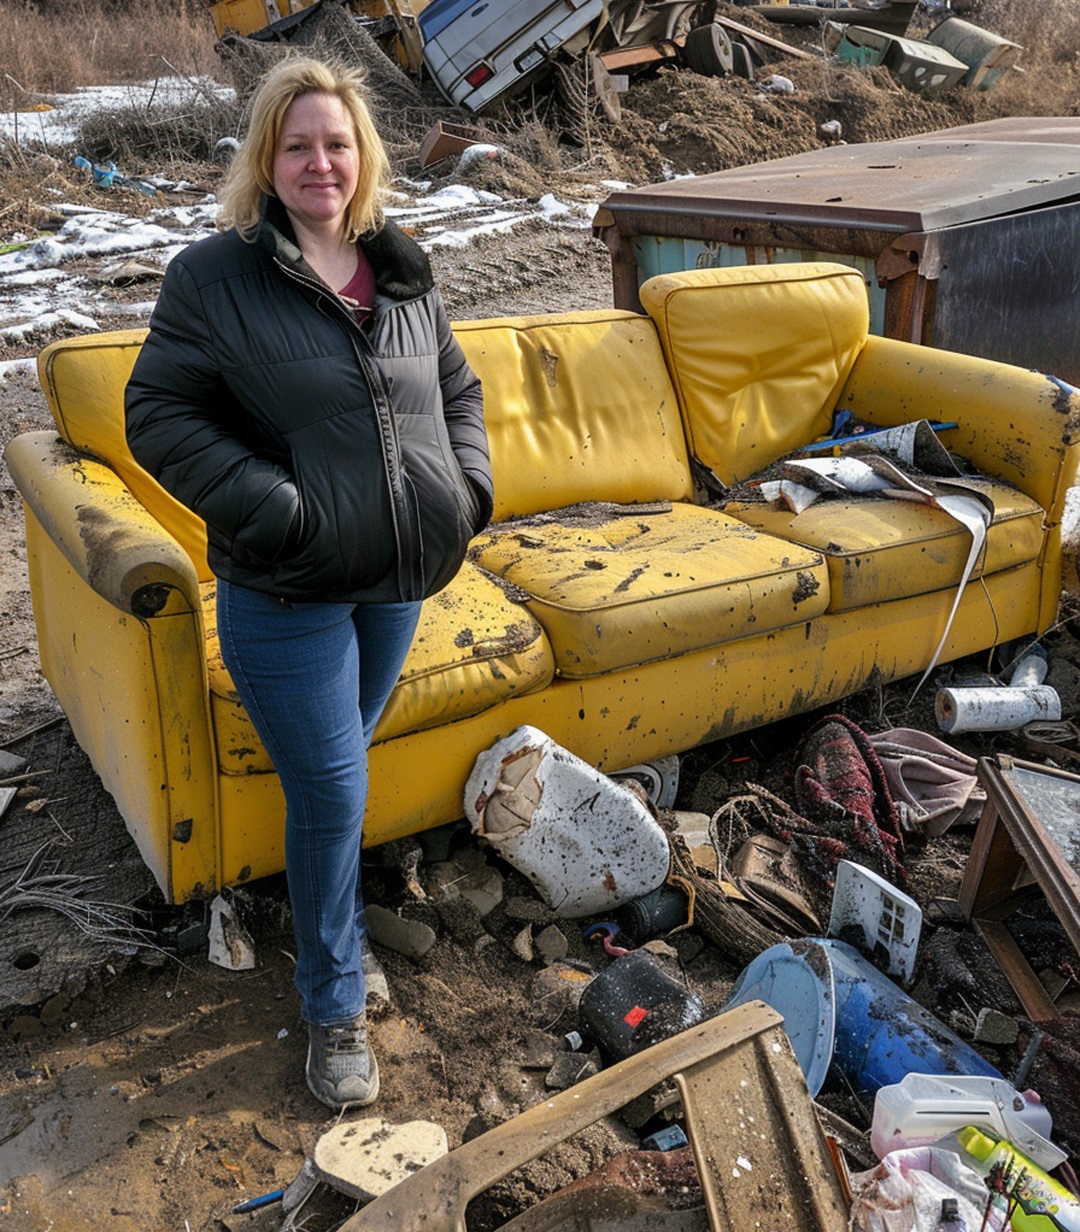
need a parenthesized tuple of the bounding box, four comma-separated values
(126, 201, 491, 602)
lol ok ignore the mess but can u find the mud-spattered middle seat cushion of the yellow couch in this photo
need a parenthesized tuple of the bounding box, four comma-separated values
(472, 504, 829, 676)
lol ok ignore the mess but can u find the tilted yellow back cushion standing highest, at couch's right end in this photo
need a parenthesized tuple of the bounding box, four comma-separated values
(639, 261, 869, 483)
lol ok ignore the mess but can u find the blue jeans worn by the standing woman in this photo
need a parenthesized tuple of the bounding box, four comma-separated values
(218, 580, 420, 1026)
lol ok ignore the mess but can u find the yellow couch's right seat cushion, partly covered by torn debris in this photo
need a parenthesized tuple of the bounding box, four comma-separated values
(724, 480, 1043, 612)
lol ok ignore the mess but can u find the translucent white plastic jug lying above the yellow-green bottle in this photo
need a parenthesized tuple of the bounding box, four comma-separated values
(869, 1073, 1068, 1170)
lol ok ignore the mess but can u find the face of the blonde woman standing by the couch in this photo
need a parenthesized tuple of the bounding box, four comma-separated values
(273, 91, 360, 230)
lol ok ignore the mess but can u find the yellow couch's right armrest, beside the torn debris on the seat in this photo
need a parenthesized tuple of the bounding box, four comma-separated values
(836, 335, 1080, 525)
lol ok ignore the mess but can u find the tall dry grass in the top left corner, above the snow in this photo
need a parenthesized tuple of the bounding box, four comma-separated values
(0, 0, 220, 100)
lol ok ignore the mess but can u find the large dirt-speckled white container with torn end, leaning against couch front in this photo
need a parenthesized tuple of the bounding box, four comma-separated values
(464, 727, 671, 919)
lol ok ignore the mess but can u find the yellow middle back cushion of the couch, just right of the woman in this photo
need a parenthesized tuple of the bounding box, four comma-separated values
(453, 309, 692, 521)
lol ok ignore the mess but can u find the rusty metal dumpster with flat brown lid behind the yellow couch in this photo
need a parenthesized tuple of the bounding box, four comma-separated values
(594, 117, 1080, 384)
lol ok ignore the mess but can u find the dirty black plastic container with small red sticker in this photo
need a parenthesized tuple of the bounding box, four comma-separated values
(579, 950, 707, 1061)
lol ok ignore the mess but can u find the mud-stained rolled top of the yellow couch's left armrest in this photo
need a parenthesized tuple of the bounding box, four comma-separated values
(4, 431, 199, 620)
